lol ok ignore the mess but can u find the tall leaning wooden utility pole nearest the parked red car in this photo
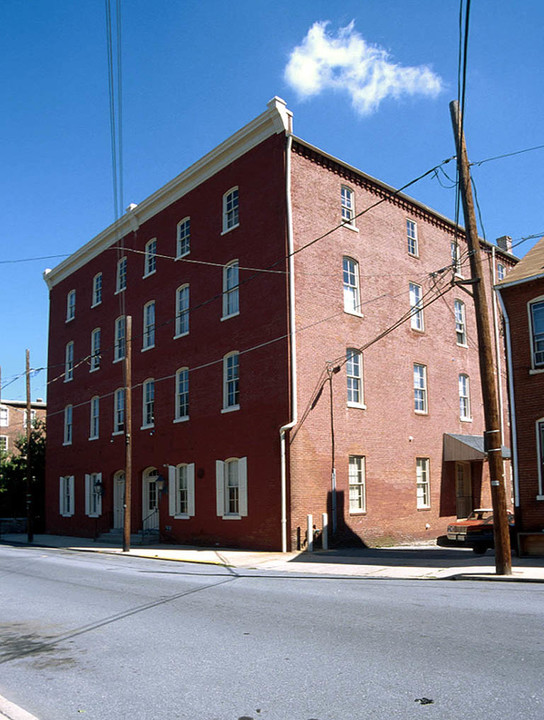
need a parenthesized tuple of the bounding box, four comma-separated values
(450, 101, 512, 575)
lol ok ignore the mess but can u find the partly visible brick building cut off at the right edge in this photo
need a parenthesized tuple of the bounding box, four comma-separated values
(496, 239, 544, 552)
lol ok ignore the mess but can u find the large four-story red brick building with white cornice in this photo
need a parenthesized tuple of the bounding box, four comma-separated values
(42, 98, 515, 549)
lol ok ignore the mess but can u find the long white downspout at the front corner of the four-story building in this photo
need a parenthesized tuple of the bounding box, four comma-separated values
(280, 132, 297, 552)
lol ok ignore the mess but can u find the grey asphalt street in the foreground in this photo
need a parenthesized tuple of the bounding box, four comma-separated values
(0, 546, 544, 720)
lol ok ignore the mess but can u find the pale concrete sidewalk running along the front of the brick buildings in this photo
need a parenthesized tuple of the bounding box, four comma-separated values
(0, 533, 544, 582)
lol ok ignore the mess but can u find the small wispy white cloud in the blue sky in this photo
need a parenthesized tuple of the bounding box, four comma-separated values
(285, 21, 442, 115)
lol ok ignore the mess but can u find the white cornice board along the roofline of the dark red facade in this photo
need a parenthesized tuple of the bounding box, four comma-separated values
(44, 97, 292, 289)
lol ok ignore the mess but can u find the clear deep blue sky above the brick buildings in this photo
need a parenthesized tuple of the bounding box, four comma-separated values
(0, 0, 544, 399)
